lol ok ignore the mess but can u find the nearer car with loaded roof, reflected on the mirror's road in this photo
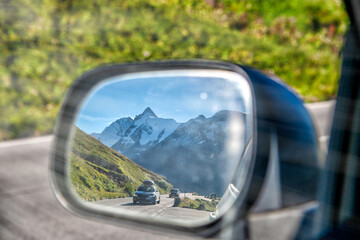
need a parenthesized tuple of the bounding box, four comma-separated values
(133, 184, 160, 205)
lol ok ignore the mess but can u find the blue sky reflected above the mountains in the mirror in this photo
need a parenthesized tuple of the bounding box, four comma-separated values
(75, 72, 250, 133)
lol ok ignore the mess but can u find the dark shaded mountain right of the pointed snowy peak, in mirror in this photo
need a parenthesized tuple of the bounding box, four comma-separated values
(134, 110, 245, 194)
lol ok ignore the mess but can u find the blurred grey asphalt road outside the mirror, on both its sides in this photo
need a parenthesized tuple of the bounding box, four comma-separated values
(0, 102, 334, 240)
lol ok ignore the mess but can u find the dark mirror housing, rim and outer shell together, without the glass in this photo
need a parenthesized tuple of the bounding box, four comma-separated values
(50, 60, 319, 237)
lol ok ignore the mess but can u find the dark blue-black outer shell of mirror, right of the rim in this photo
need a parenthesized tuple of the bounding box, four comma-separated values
(241, 66, 321, 210)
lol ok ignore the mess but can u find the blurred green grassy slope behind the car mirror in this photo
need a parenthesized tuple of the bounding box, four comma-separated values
(0, 0, 348, 140)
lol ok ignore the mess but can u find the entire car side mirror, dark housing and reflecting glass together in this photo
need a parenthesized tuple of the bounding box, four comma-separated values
(51, 60, 318, 236)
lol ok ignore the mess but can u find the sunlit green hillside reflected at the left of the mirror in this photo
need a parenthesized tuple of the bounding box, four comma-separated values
(71, 128, 172, 201)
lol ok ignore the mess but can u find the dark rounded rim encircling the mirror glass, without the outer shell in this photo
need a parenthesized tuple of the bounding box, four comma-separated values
(50, 60, 260, 237)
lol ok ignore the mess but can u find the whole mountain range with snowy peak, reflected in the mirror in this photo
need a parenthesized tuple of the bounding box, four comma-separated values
(93, 108, 246, 195)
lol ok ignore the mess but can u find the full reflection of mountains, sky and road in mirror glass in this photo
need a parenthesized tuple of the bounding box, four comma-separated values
(70, 70, 253, 225)
